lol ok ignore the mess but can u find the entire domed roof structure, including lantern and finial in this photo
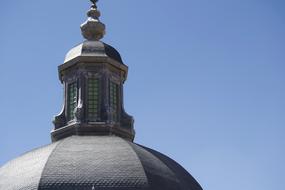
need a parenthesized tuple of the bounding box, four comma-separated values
(0, 0, 202, 190)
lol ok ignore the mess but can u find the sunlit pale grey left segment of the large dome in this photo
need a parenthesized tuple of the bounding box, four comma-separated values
(0, 143, 58, 190)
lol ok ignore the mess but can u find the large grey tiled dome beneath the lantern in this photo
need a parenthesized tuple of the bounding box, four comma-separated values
(0, 136, 202, 190)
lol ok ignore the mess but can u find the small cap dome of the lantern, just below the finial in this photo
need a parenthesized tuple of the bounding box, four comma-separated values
(64, 40, 123, 64)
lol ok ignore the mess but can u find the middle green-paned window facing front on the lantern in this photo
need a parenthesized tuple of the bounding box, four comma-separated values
(87, 78, 100, 121)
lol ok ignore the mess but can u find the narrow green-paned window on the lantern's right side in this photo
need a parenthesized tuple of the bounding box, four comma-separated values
(109, 81, 119, 121)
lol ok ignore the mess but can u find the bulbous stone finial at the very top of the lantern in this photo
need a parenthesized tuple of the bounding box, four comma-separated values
(80, 0, 105, 41)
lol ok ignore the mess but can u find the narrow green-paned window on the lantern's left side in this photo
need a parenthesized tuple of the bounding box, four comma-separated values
(67, 82, 77, 121)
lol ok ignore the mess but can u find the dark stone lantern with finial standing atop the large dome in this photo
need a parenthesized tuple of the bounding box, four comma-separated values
(51, 0, 135, 141)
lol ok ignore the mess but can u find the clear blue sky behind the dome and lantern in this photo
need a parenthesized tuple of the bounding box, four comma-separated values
(0, 0, 285, 190)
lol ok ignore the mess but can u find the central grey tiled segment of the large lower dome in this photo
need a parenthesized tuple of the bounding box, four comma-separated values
(39, 136, 147, 190)
